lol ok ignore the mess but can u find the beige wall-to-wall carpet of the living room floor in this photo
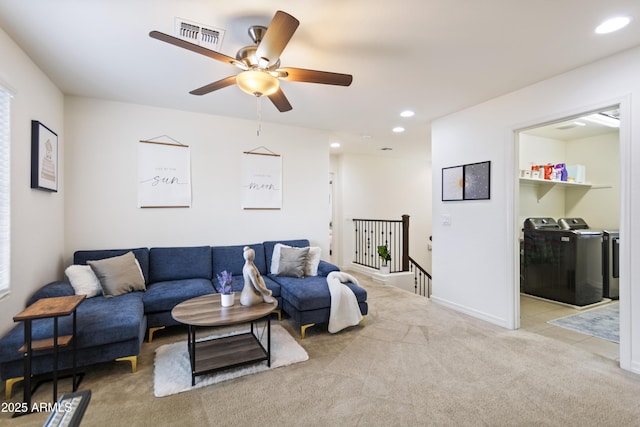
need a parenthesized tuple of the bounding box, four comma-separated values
(0, 275, 640, 427)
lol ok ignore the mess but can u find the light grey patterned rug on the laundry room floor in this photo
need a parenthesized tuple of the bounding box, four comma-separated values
(547, 302, 620, 343)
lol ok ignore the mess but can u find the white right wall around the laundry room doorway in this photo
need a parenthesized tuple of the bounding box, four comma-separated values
(432, 49, 640, 372)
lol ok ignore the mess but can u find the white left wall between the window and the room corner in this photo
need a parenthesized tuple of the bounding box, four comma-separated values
(0, 29, 65, 334)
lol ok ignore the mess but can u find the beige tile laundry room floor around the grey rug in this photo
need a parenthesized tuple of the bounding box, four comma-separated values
(520, 295, 620, 361)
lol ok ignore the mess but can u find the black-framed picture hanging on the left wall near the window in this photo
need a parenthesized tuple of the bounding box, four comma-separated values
(31, 120, 59, 192)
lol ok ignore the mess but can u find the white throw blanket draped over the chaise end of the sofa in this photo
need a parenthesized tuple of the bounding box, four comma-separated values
(327, 271, 362, 334)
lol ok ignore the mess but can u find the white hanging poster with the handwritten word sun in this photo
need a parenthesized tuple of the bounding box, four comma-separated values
(138, 141, 191, 208)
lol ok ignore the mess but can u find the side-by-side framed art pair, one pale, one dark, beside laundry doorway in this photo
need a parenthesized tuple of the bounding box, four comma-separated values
(442, 161, 491, 202)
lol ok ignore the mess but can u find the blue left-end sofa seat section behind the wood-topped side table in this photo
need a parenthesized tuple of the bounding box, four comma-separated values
(0, 292, 144, 362)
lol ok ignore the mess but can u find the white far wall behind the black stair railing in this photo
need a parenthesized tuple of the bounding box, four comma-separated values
(331, 149, 431, 272)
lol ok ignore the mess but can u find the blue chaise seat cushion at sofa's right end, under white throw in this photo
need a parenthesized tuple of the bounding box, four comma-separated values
(274, 276, 367, 311)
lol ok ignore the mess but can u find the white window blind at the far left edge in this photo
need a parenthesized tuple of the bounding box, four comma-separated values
(0, 86, 11, 296)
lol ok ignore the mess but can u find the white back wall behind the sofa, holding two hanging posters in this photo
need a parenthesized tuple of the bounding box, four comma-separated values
(65, 97, 329, 262)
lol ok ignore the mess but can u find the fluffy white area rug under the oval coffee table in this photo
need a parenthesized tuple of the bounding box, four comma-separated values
(153, 325, 309, 397)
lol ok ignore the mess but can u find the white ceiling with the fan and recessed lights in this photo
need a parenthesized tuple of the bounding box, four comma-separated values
(0, 0, 640, 151)
